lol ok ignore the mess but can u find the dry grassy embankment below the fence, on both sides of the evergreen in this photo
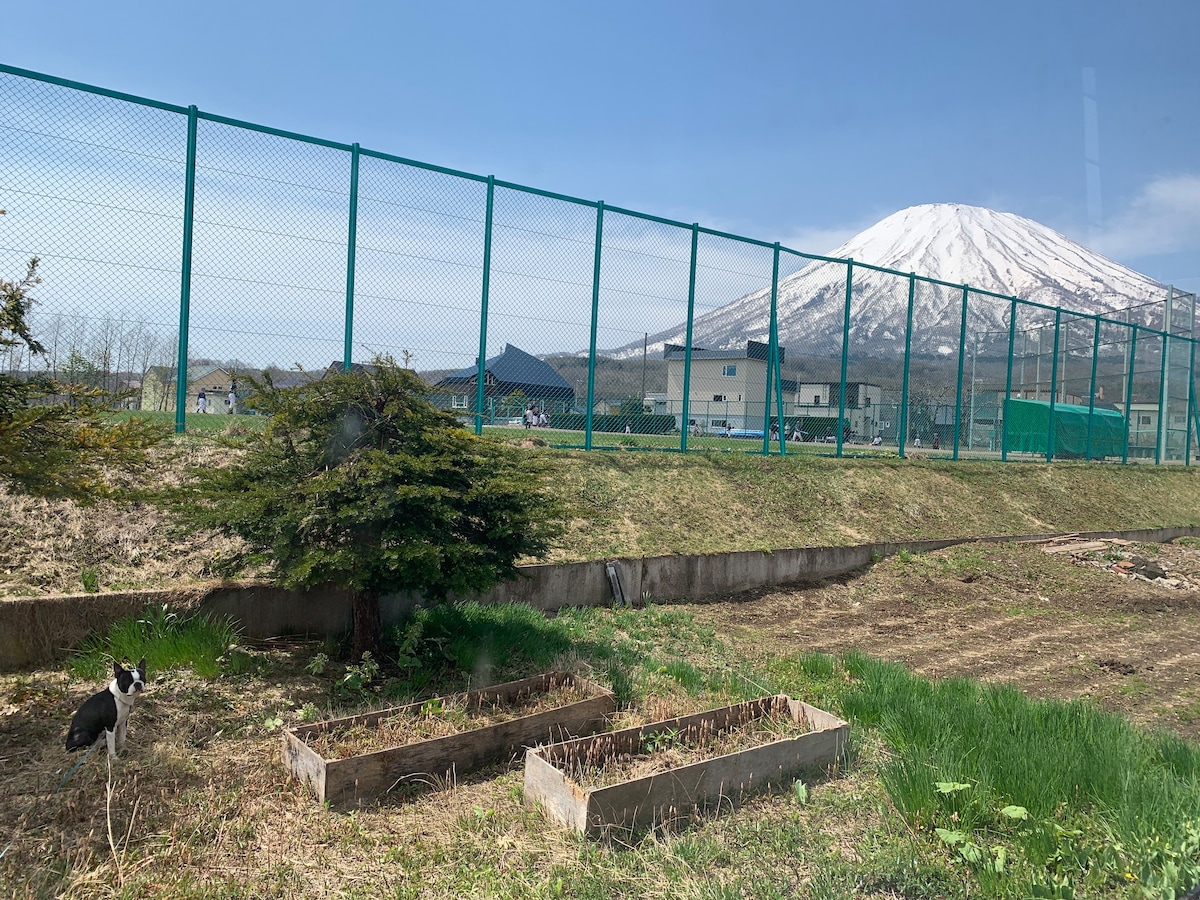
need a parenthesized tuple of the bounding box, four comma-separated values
(7, 439, 1200, 595)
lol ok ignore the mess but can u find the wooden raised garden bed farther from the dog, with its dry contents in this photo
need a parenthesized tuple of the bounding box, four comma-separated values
(524, 695, 850, 834)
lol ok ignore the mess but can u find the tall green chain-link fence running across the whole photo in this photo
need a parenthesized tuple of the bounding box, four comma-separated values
(0, 66, 1200, 464)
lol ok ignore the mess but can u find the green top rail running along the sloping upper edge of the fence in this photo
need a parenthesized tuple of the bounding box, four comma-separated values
(0, 62, 1185, 343)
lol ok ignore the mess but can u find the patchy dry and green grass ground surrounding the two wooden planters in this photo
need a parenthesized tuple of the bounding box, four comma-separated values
(9, 605, 1200, 900)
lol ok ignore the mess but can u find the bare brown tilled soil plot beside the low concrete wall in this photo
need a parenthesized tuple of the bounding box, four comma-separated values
(697, 545, 1200, 739)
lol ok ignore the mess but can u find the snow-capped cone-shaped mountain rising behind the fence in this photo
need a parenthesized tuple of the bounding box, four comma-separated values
(613, 203, 1166, 356)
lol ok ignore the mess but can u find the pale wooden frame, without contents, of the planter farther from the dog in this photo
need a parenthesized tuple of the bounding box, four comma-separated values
(524, 695, 850, 835)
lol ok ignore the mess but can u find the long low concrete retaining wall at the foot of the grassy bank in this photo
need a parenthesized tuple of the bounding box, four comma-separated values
(0, 526, 1200, 668)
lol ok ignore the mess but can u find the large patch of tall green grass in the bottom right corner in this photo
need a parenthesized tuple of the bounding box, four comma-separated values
(840, 653, 1200, 896)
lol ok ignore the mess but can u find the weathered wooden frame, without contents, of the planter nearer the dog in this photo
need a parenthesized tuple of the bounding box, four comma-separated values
(283, 672, 616, 804)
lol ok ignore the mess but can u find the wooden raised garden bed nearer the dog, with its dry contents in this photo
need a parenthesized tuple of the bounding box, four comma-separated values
(283, 672, 616, 804)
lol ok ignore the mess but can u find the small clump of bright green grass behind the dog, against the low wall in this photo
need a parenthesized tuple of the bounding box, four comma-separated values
(71, 605, 239, 679)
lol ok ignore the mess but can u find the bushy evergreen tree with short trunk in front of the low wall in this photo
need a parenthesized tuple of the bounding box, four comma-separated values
(180, 358, 557, 656)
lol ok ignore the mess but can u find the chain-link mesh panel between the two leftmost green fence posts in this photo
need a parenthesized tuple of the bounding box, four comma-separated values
(187, 119, 350, 414)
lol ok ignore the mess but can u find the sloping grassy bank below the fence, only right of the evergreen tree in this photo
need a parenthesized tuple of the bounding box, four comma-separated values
(540, 452, 1200, 560)
